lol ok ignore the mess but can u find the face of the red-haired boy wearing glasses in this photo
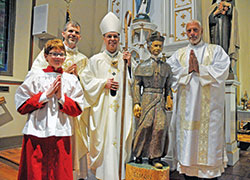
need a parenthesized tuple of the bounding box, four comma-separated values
(44, 48, 65, 70)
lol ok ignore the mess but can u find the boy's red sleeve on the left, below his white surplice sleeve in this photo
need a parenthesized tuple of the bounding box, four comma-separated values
(18, 92, 45, 114)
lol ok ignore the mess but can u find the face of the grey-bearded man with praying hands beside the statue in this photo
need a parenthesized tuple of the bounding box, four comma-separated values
(186, 21, 203, 45)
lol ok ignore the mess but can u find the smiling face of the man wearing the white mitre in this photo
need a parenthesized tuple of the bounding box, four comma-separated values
(103, 32, 120, 53)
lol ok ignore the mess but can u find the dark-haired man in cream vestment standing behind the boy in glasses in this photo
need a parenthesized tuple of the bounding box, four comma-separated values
(31, 20, 88, 179)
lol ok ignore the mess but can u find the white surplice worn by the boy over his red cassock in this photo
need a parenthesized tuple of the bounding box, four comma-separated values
(15, 70, 83, 138)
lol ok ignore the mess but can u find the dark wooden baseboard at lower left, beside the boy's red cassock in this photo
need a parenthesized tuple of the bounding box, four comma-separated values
(0, 135, 23, 151)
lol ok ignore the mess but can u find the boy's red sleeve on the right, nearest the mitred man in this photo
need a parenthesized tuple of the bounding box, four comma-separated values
(60, 95, 82, 117)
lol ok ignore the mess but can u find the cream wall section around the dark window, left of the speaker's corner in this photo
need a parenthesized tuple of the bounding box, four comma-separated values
(0, 0, 32, 138)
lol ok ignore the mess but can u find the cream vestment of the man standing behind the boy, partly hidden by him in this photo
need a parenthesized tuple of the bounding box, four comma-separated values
(31, 45, 88, 179)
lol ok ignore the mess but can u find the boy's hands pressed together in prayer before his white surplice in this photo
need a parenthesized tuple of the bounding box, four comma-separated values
(46, 75, 61, 99)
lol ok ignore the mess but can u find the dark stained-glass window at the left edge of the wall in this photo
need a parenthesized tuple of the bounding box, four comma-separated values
(0, 0, 16, 76)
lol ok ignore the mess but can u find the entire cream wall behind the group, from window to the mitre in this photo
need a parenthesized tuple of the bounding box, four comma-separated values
(0, 0, 108, 139)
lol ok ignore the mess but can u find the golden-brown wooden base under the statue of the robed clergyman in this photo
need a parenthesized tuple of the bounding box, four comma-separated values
(126, 163, 169, 180)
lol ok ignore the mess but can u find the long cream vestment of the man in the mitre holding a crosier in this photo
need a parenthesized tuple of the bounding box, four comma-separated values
(80, 50, 133, 180)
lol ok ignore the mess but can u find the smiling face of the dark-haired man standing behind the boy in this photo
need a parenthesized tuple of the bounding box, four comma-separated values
(62, 24, 81, 49)
